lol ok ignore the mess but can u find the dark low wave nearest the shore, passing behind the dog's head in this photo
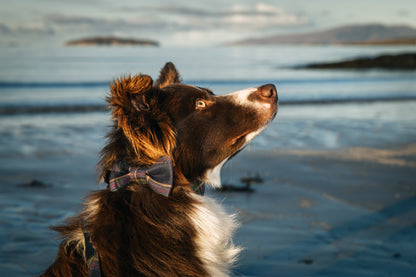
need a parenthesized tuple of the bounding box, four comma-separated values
(0, 96, 416, 115)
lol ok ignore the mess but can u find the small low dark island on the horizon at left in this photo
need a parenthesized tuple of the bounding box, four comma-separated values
(65, 36, 159, 46)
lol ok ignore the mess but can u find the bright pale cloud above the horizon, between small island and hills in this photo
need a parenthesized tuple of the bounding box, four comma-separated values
(151, 4, 310, 44)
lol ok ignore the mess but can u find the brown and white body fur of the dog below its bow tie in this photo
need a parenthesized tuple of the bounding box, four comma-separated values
(43, 182, 240, 277)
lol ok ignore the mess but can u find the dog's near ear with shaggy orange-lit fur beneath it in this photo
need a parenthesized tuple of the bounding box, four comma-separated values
(102, 75, 175, 164)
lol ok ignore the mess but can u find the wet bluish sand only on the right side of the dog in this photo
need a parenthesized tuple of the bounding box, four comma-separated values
(219, 144, 416, 276)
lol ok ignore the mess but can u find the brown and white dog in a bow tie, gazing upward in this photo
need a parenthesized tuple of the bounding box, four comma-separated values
(41, 62, 278, 277)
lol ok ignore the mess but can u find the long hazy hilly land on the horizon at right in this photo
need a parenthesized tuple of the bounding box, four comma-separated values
(226, 24, 416, 46)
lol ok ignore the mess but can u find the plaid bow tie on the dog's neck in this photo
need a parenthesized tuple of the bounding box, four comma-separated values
(108, 156, 173, 196)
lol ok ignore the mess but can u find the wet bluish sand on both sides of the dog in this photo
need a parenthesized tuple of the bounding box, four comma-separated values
(0, 144, 416, 276)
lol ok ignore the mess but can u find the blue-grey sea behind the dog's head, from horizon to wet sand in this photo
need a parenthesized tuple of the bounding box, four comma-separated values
(0, 46, 416, 153)
